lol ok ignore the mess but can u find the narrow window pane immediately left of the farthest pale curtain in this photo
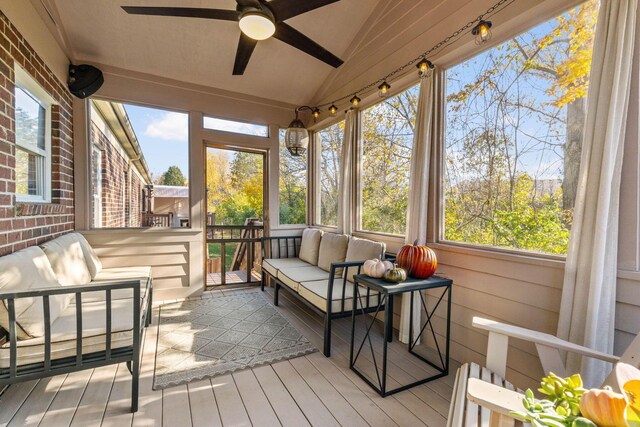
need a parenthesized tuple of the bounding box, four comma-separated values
(317, 121, 344, 227)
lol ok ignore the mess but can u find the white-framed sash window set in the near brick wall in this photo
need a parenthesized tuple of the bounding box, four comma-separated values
(15, 68, 52, 202)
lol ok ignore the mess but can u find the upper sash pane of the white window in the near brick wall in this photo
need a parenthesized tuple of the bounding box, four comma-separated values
(16, 86, 47, 150)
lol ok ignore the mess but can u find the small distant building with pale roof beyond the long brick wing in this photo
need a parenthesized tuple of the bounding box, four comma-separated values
(146, 185, 189, 227)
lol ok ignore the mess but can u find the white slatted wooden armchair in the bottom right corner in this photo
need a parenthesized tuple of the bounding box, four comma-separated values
(447, 317, 640, 427)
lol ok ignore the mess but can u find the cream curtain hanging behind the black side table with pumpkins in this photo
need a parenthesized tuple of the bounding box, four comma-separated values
(399, 70, 436, 343)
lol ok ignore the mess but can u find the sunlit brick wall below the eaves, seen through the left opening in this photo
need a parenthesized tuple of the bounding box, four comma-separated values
(91, 123, 144, 228)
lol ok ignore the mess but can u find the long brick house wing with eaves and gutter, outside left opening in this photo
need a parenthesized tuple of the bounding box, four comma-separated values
(90, 100, 152, 228)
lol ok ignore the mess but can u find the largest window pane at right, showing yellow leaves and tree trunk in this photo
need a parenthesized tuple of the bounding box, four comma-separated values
(443, 1, 598, 254)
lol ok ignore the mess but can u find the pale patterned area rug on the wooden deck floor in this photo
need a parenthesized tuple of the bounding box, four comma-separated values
(153, 291, 317, 390)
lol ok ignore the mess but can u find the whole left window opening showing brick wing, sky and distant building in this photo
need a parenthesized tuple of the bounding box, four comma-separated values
(90, 99, 190, 228)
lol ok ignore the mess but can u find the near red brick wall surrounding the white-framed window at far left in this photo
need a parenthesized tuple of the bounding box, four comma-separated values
(0, 12, 74, 255)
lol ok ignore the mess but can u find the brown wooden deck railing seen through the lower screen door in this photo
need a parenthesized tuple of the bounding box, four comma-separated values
(207, 219, 264, 286)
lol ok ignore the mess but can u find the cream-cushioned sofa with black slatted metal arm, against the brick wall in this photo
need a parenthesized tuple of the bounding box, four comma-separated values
(0, 233, 153, 412)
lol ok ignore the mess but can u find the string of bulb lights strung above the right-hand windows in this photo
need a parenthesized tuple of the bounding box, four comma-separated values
(306, 0, 515, 117)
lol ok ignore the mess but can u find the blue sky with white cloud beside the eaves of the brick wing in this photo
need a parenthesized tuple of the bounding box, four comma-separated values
(124, 104, 189, 182)
